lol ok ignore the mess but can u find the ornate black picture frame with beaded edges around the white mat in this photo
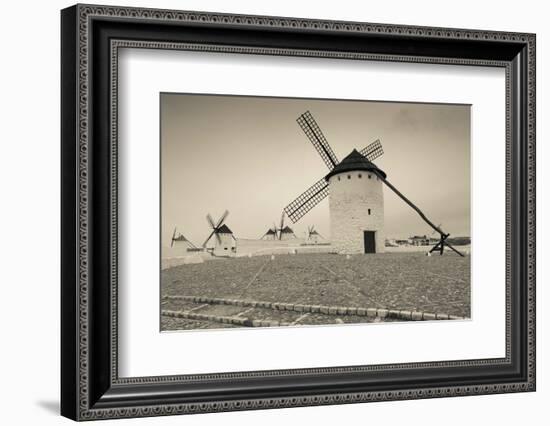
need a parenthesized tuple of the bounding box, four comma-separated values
(61, 5, 535, 420)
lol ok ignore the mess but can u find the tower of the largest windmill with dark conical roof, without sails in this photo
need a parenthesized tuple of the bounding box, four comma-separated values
(325, 149, 386, 254)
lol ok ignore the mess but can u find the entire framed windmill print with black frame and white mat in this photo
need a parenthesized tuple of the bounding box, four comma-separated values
(61, 5, 535, 420)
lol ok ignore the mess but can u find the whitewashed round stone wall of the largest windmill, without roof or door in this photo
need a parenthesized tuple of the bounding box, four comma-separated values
(329, 171, 385, 254)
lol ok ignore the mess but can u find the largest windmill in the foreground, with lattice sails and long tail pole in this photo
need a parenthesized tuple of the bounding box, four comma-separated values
(284, 111, 463, 256)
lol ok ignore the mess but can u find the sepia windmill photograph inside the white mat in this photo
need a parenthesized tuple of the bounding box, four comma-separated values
(160, 93, 475, 331)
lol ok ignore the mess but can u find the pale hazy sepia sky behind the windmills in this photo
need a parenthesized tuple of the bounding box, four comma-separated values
(160, 93, 470, 246)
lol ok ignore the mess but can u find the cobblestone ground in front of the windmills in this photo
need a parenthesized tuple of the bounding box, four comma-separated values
(161, 253, 470, 330)
